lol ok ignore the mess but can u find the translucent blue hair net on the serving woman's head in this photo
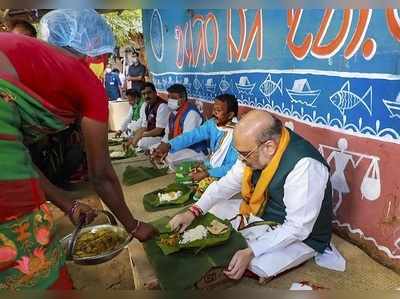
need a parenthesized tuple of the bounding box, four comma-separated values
(40, 9, 115, 57)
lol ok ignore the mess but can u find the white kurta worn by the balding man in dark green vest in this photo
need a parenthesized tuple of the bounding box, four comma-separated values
(196, 158, 344, 277)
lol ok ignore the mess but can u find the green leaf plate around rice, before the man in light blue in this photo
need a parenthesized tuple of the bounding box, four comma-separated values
(143, 183, 194, 212)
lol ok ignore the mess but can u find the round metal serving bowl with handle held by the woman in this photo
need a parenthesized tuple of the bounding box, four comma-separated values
(60, 210, 133, 265)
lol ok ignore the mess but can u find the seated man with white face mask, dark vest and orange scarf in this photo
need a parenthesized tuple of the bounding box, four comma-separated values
(149, 84, 207, 169)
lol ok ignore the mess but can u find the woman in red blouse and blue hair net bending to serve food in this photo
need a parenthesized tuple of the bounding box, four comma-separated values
(0, 9, 154, 290)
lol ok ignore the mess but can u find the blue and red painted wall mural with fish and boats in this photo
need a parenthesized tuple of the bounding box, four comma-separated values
(143, 9, 400, 271)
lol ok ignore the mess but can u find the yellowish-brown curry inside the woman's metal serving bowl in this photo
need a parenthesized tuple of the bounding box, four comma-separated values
(74, 229, 125, 258)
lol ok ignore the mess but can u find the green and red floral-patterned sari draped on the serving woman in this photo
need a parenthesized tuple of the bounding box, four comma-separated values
(0, 73, 66, 291)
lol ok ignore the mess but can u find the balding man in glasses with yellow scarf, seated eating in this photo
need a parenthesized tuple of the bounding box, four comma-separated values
(170, 111, 332, 280)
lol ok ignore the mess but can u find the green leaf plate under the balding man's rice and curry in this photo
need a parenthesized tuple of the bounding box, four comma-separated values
(157, 213, 232, 255)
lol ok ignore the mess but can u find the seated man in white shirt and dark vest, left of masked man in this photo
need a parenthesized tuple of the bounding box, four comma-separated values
(124, 82, 171, 151)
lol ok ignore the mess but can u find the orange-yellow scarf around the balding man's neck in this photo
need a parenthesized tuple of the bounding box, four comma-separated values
(240, 128, 290, 216)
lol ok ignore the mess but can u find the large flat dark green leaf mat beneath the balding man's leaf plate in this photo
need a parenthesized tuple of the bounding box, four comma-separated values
(143, 213, 247, 290)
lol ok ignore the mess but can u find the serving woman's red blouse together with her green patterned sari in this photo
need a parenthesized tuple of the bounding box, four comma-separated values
(0, 33, 108, 291)
